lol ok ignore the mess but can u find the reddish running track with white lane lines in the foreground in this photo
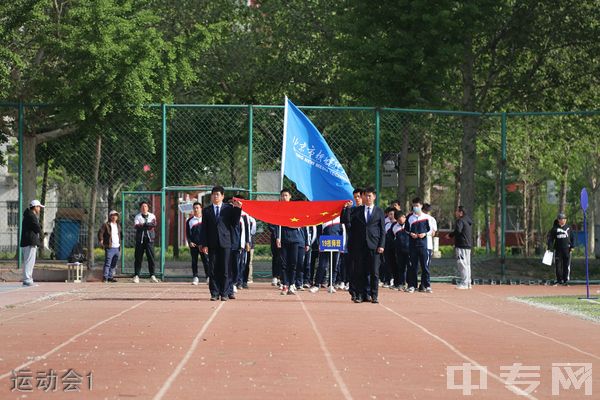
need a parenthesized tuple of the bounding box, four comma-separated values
(0, 283, 600, 399)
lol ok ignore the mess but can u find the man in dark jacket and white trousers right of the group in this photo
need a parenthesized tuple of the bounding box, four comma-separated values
(448, 206, 473, 289)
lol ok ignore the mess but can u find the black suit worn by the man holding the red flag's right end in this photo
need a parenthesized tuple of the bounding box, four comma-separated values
(341, 206, 385, 299)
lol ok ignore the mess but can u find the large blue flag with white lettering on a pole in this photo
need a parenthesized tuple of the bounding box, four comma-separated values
(282, 97, 354, 200)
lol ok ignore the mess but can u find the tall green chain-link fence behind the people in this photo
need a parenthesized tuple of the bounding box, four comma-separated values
(0, 104, 600, 279)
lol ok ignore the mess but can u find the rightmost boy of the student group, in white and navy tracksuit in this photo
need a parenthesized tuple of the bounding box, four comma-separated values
(405, 197, 432, 293)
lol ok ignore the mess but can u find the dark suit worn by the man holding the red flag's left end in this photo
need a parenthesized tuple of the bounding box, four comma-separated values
(200, 203, 242, 297)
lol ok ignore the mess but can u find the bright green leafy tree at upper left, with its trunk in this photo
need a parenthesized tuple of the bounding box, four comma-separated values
(1, 0, 196, 262)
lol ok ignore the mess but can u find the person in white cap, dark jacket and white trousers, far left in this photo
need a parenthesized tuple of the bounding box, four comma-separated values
(20, 200, 44, 286)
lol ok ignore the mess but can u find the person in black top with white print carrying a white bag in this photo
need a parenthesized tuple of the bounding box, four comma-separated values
(548, 213, 575, 286)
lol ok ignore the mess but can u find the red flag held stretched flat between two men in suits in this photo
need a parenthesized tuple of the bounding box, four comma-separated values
(237, 199, 350, 228)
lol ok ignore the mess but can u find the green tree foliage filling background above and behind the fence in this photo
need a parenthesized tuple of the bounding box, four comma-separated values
(0, 0, 600, 256)
